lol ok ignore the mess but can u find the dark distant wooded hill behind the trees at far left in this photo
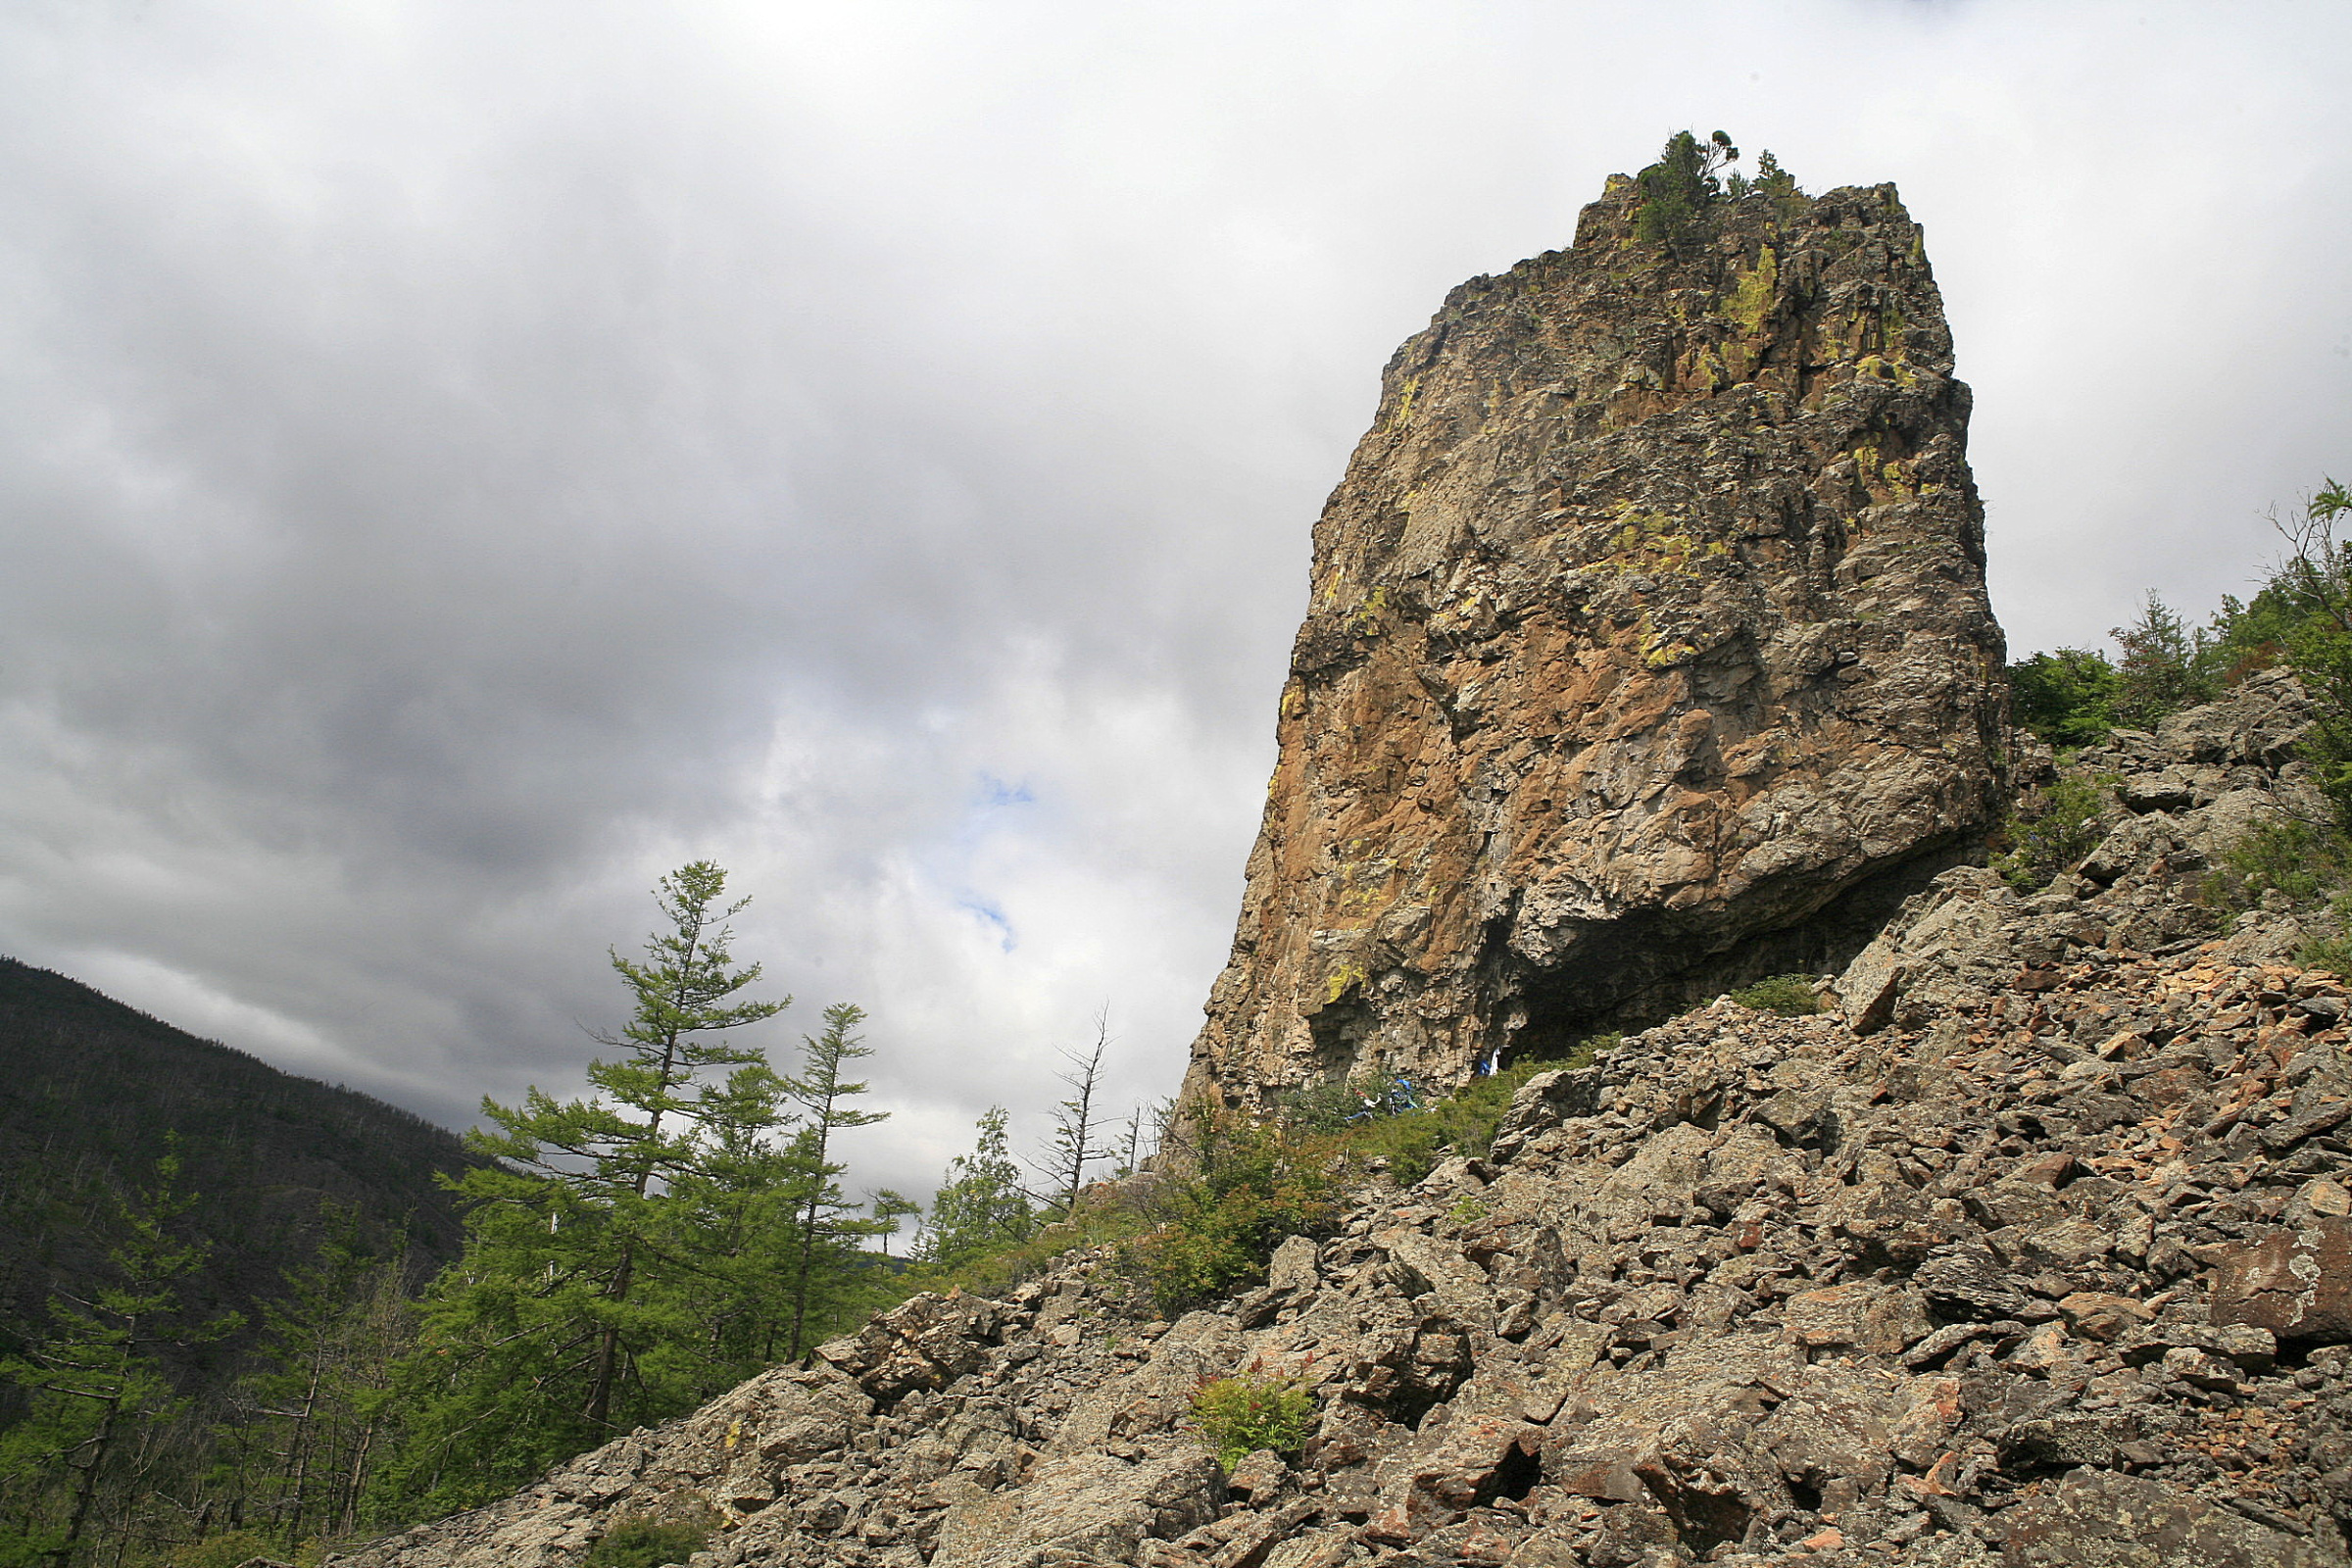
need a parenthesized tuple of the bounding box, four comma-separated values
(0, 959, 472, 1371)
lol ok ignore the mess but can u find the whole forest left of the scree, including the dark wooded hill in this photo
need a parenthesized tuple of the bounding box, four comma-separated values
(0, 860, 912, 1568)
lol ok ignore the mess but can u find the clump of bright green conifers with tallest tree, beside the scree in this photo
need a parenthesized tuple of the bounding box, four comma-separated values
(378, 860, 889, 1514)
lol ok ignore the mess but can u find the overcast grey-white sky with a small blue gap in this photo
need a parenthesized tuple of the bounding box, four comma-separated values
(0, 0, 2352, 1195)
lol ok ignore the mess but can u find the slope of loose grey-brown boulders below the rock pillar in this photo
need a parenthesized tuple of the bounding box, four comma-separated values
(334, 679, 2352, 1568)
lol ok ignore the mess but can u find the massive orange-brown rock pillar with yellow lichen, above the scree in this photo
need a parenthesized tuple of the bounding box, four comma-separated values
(1188, 178, 2001, 1102)
